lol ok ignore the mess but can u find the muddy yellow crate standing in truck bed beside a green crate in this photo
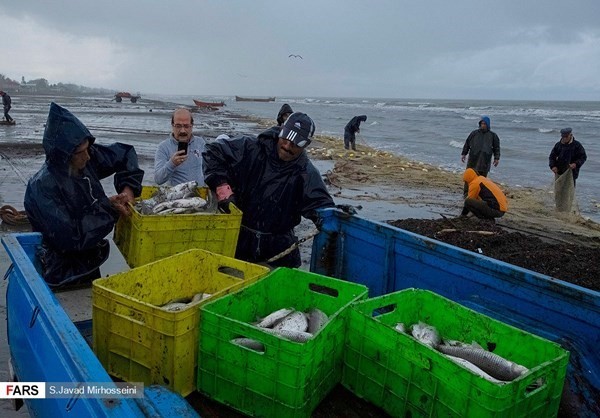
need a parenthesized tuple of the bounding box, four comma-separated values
(92, 249, 269, 396)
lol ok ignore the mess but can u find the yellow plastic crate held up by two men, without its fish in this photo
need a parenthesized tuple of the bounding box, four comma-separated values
(114, 186, 242, 267)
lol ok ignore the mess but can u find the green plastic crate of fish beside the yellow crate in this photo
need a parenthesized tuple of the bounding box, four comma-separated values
(197, 268, 368, 417)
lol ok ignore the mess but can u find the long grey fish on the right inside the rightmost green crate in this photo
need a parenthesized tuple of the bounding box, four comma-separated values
(437, 344, 529, 382)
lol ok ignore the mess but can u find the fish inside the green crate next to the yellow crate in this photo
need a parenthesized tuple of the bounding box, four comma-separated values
(231, 308, 329, 352)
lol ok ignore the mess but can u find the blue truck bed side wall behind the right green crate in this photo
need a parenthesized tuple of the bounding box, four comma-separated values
(310, 209, 600, 417)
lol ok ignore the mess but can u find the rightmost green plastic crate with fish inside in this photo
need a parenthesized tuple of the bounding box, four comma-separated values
(342, 289, 569, 418)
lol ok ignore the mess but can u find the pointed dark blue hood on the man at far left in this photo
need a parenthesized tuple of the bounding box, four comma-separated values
(43, 102, 96, 168)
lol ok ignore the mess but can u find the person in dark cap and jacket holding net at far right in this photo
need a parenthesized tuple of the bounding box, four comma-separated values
(548, 128, 587, 212)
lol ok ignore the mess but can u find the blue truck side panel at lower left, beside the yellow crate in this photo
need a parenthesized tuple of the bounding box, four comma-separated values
(2, 233, 198, 417)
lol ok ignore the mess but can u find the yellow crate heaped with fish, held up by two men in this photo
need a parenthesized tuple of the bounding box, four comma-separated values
(114, 182, 242, 267)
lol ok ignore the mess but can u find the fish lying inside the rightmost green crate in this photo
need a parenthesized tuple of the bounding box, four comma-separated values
(394, 322, 529, 384)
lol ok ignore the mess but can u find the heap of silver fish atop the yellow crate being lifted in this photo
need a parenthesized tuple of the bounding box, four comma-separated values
(135, 181, 217, 215)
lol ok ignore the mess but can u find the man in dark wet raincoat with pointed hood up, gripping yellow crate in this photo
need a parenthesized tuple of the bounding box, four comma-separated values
(25, 103, 144, 287)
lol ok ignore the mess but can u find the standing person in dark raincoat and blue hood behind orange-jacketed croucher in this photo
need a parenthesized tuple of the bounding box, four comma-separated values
(460, 116, 500, 196)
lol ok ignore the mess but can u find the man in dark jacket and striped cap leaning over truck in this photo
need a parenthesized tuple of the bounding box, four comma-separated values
(203, 113, 334, 267)
